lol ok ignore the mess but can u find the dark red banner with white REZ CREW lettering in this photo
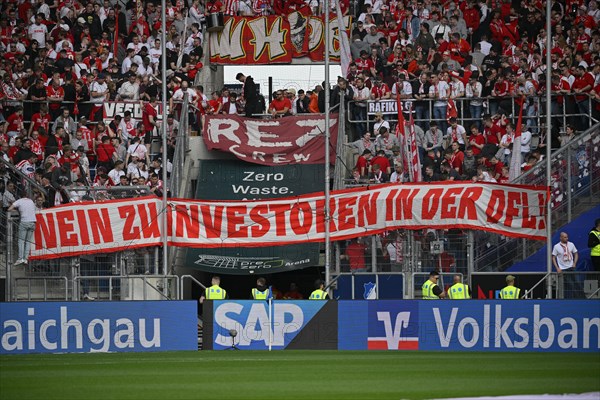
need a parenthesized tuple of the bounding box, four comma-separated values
(202, 114, 338, 165)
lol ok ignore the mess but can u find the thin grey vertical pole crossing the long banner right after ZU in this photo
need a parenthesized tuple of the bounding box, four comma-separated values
(160, 0, 168, 276)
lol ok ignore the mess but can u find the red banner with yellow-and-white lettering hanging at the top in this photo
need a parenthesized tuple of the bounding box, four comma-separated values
(209, 11, 351, 65)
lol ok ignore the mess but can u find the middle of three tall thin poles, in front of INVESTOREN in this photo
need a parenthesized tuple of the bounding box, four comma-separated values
(323, 0, 331, 298)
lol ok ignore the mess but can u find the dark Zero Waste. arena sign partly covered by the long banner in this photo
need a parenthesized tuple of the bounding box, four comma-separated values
(187, 160, 325, 275)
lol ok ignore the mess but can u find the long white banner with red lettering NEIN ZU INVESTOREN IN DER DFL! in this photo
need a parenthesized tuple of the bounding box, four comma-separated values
(31, 183, 548, 259)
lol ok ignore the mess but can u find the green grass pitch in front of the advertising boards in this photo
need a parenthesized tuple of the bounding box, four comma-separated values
(0, 351, 600, 400)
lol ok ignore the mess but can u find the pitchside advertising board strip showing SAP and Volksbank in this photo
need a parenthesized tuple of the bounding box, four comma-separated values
(204, 300, 600, 352)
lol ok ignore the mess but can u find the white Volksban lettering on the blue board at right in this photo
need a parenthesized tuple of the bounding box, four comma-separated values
(432, 304, 600, 350)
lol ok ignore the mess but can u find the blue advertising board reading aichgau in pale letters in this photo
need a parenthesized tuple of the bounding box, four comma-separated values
(0, 301, 198, 354)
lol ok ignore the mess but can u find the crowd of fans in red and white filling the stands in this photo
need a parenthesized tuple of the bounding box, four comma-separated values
(0, 0, 600, 206)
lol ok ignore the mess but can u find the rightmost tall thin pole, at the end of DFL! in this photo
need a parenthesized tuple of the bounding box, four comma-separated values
(540, 0, 552, 299)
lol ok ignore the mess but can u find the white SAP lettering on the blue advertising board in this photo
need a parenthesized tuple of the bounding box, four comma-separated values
(214, 302, 304, 346)
